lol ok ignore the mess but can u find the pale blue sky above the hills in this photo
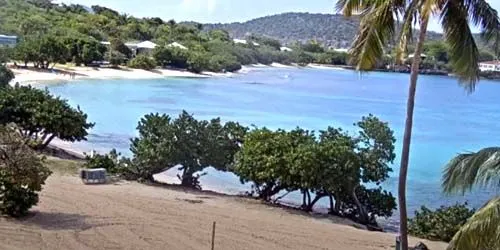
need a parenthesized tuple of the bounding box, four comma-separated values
(62, 0, 500, 31)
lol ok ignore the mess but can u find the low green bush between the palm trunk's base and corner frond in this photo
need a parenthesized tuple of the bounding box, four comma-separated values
(408, 203, 475, 242)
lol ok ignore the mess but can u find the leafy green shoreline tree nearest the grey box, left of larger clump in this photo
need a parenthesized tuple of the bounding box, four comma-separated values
(129, 111, 247, 188)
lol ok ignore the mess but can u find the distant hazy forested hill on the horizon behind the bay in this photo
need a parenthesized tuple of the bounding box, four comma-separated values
(204, 13, 441, 48)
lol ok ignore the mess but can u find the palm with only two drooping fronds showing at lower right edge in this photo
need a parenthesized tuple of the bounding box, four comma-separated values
(443, 147, 500, 250)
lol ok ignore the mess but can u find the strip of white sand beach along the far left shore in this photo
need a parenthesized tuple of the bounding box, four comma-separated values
(11, 67, 209, 84)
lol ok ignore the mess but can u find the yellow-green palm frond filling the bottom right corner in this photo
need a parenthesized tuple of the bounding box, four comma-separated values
(448, 197, 500, 250)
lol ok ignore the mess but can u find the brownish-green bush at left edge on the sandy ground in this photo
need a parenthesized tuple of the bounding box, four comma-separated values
(0, 126, 51, 217)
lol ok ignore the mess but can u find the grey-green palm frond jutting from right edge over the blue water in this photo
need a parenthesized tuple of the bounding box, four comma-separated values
(442, 147, 500, 193)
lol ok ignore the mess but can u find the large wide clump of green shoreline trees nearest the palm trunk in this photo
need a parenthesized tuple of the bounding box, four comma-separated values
(232, 115, 396, 224)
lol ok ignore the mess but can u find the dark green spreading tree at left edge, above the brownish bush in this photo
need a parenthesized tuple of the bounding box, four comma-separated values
(0, 85, 94, 149)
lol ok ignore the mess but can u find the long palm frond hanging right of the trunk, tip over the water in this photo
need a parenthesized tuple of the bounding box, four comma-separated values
(441, 0, 479, 92)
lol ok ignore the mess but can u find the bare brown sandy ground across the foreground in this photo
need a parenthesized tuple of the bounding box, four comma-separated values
(0, 175, 445, 250)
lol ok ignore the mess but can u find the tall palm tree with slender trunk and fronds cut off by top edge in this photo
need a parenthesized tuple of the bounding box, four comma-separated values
(337, 0, 500, 250)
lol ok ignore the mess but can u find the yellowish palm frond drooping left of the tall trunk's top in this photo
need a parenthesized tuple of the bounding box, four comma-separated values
(350, 1, 397, 71)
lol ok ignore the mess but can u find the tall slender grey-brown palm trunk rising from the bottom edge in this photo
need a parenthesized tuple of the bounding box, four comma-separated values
(398, 17, 429, 250)
